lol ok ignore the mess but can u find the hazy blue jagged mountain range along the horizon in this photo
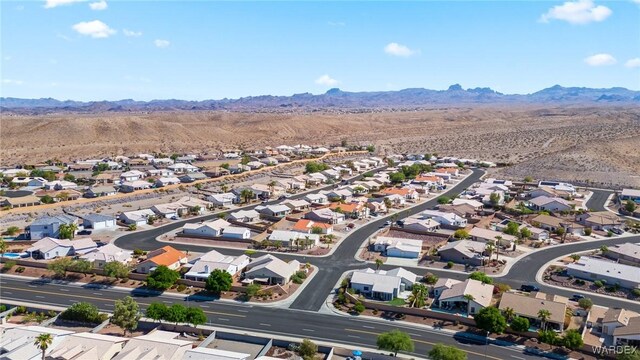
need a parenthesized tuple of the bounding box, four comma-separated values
(0, 84, 640, 114)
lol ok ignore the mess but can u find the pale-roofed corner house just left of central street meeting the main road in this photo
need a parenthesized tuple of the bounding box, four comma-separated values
(244, 254, 300, 285)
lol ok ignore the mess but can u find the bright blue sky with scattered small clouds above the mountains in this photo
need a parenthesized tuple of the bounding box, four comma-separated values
(0, 0, 640, 101)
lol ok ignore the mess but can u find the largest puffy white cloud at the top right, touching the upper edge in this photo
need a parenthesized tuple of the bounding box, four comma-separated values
(540, 0, 612, 24)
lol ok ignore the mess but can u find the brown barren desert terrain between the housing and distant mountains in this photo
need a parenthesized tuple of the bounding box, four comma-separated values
(0, 104, 640, 187)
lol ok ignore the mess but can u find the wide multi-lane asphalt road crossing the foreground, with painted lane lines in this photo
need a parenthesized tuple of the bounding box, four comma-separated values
(0, 276, 532, 360)
